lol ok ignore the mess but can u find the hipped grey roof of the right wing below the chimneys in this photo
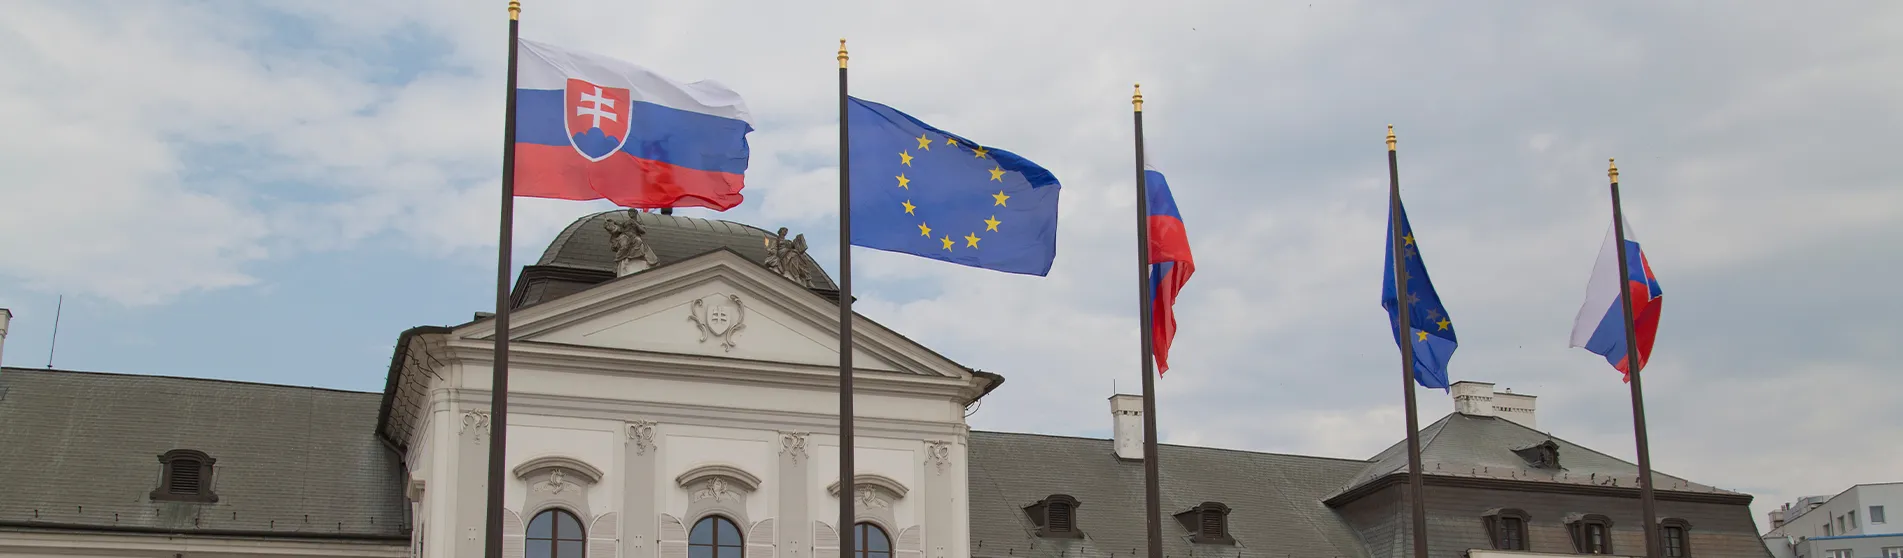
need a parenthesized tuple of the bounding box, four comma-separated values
(1328, 413, 1736, 497)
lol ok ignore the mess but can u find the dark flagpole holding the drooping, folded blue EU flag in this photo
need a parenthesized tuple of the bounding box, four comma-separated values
(1387, 124, 1427, 558)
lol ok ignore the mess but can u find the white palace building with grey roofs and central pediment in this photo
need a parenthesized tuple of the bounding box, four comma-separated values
(0, 211, 1770, 558)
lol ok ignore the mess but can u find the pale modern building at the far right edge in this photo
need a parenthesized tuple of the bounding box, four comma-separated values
(1764, 482, 1903, 558)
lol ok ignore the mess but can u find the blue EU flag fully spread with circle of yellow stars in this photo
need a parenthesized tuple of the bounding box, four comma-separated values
(847, 97, 1058, 276)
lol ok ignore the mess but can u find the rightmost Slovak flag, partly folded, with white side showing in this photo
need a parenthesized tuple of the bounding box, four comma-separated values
(1572, 215, 1663, 381)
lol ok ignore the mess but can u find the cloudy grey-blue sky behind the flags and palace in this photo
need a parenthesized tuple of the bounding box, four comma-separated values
(0, 0, 1903, 524)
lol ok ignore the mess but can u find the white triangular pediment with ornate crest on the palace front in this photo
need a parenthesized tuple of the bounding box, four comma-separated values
(459, 249, 969, 377)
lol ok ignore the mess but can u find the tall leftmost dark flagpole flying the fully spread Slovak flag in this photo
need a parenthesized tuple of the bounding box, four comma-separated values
(483, 0, 521, 558)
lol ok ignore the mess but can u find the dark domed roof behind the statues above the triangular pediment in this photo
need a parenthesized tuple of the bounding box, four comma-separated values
(535, 209, 837, 289)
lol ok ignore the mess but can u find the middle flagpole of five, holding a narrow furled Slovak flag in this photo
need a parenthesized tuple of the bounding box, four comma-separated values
(1130, 84, 1163, 558)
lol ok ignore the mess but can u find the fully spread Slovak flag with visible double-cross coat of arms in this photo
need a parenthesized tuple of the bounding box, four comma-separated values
(514, 40, 754, 211)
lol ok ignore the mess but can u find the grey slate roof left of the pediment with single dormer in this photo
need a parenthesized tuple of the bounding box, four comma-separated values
(0, 368, 409, 541)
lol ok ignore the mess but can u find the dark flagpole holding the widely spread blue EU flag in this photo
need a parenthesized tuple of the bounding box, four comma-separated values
(839, 38, 858, 558)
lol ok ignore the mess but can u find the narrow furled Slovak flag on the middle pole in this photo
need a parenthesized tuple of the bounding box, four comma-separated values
(1144, 149, 1195, 375)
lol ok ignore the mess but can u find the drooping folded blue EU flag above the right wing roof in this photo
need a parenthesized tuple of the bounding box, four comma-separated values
(1382, 204, 1460, 389)
